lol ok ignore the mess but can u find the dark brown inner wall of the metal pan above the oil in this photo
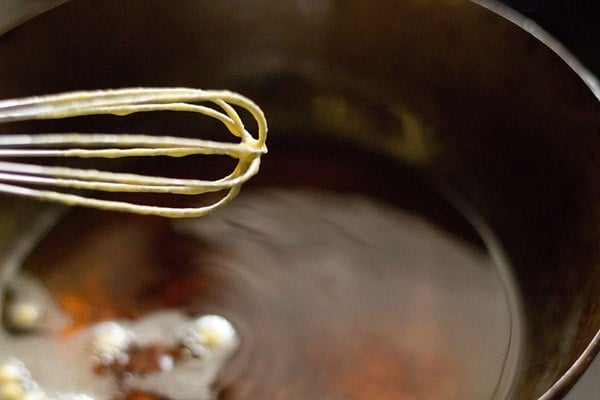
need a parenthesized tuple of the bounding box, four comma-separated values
(0, 0, 600, 398)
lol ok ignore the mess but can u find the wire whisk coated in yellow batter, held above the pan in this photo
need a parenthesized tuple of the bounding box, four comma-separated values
(0, 88, 267, 218)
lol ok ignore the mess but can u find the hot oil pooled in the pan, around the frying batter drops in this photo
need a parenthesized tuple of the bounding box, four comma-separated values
(0, 141, 520, 400)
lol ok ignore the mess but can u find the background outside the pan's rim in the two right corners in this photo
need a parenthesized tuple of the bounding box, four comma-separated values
(503, 0, 600, 400)
